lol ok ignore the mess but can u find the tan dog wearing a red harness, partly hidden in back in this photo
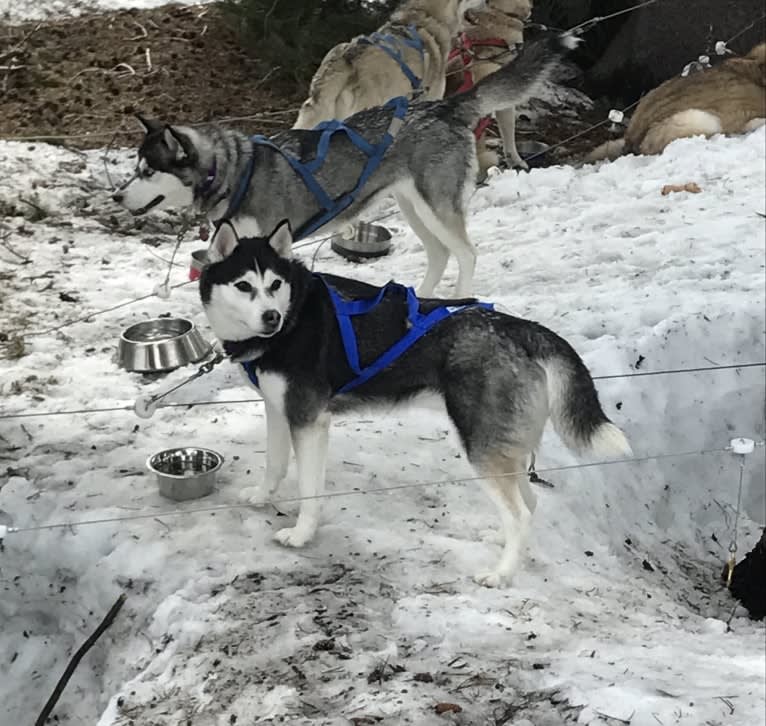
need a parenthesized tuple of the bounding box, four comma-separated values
(447, 0, 532, 176)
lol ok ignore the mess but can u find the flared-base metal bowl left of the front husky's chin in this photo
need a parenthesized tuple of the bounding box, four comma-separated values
(118, 318, 211, 372)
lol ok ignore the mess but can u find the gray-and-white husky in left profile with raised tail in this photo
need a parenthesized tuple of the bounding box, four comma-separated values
(114, 34, 577, 296)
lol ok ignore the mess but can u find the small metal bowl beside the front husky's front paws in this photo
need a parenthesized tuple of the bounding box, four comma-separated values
(146, 446, 223, 502)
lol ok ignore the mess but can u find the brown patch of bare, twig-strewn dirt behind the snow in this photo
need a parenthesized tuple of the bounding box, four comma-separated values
(0, 5, 303, 148)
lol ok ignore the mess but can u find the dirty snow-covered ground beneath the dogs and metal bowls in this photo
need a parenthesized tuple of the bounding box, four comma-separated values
(0, 130, 766, 726)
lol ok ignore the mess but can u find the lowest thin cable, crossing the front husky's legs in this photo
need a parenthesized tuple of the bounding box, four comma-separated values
(1, 440, 730, 534)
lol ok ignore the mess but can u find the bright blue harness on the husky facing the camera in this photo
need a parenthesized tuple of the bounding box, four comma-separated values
(242, 274, 495, 395)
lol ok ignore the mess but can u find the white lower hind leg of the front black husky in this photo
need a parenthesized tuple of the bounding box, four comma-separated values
(475, 449, 536, 587)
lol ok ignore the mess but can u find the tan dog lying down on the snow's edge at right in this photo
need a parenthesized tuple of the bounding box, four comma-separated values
(587, 43, 766, 161)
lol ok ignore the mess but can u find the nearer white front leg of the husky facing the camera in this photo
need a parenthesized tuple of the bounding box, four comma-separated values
(274, 413, 330, 547)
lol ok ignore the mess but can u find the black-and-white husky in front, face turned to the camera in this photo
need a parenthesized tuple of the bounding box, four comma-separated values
(200, 221, 630, 587)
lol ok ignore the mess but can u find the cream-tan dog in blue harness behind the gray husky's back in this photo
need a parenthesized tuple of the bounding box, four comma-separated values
(293, 0, 484, 129)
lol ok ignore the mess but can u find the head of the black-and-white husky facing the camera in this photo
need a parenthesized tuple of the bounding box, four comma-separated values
(200, 220, 294, 342)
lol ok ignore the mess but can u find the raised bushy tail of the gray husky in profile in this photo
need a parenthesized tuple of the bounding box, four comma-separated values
(448, 31, 580, 127)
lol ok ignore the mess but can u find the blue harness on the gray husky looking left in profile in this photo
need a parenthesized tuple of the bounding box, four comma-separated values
(219, 96, 409, 240)
